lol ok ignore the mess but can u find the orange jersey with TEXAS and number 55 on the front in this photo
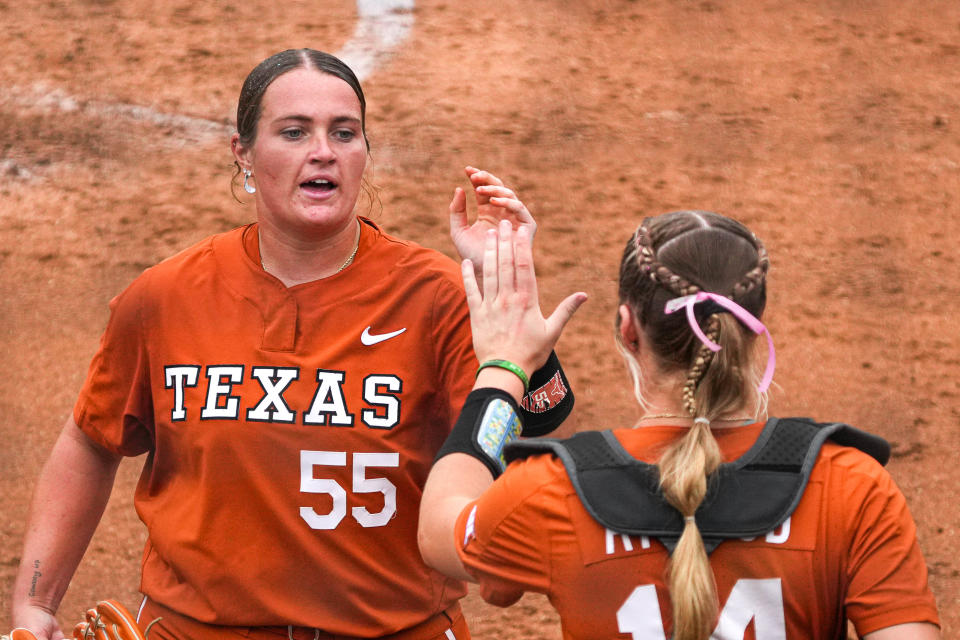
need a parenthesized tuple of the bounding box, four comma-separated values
(74, 220, 477, 637)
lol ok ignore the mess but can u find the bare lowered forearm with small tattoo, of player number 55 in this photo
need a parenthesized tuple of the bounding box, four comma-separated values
(12, 417, 121, 640)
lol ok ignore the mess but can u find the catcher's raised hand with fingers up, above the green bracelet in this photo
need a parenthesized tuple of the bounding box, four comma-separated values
(462, 220, 587, 375)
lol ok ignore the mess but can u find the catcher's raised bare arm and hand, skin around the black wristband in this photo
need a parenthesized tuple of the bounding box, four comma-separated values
(418, 221, 587, 579)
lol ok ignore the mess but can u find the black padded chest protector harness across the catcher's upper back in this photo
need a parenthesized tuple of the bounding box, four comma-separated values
(506, 418, 890, 553)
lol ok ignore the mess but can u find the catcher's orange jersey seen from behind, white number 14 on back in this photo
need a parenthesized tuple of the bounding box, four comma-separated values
(455, 424, 939, 640)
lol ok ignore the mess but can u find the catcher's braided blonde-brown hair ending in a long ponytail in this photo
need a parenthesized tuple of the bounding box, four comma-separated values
(618, 211, 770, 640)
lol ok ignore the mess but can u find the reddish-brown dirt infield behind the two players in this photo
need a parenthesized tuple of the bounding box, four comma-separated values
(0, 0, 960, 640)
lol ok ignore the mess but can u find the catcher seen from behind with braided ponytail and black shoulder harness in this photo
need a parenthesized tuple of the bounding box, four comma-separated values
(420, 211, 939, 640)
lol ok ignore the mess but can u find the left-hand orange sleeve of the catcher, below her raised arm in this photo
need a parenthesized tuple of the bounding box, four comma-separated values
(454, 456, 565, 607)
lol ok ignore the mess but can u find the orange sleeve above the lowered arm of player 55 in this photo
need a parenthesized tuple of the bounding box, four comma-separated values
(73, 275, 153, 456)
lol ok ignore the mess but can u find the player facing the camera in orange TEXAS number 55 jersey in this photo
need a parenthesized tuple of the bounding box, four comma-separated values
(13, 50, 572, 640)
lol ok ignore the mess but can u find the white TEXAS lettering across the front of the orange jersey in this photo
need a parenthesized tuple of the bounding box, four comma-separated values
(164, 364, 403, 429)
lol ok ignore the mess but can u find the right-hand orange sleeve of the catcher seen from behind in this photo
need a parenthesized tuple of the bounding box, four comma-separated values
(838, 460, 939, 636)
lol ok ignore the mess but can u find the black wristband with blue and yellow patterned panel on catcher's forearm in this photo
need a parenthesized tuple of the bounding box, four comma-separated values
(434, 387, 523, 478)
